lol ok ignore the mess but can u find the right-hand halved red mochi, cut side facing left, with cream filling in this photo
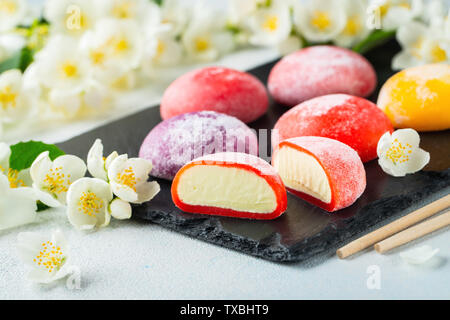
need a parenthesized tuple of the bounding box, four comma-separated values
(272, 137, 366, 212)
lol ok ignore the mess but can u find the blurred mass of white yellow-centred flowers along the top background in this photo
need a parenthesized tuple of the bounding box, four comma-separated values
(0, 0, 450, 140)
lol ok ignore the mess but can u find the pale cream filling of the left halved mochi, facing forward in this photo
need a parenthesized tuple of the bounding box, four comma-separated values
(177, 165, 277, 213)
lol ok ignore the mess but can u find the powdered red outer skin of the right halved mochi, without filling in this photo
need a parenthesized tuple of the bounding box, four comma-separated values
(281, 137, 366, 211)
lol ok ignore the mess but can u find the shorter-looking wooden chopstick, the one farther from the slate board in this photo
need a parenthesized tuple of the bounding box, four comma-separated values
(375, 211, 450, 253)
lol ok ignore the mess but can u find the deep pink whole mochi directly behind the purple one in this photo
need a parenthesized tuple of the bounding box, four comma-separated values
(161, 67, 269, 123)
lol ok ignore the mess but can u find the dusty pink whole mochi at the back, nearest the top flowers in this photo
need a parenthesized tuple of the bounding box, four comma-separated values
(268, 46, 377, 107)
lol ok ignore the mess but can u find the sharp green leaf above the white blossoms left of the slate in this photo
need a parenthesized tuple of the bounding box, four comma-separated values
(9, 141, 65, 171)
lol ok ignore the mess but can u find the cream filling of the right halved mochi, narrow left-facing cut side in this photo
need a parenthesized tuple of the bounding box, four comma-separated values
(273, 146, 331, 203)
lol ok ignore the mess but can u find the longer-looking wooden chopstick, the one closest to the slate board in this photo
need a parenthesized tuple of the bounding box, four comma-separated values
(336, 194, 450, 259)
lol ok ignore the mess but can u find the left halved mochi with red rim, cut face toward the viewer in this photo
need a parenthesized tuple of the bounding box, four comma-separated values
(172, 152, 287, 219)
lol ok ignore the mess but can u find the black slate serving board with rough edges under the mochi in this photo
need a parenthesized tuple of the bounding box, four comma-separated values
(59, 42, 450, 262)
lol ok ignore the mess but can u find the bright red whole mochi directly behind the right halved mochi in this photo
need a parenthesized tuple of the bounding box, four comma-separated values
(272, 94, 393, 162)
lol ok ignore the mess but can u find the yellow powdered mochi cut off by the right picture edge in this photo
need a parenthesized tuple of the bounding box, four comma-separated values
(377, 64, 450, 131)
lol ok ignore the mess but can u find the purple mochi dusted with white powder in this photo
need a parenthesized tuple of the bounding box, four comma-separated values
(139, 111, 258, 180)
